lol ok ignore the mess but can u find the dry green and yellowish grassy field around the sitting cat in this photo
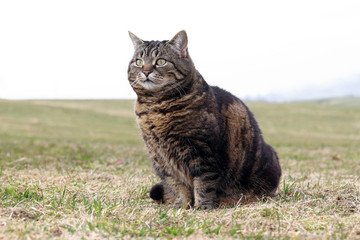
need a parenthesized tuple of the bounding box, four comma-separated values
(0, 98, 360, 239)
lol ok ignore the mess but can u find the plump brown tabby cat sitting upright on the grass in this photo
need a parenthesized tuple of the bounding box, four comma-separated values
(128, 31, 281, 209)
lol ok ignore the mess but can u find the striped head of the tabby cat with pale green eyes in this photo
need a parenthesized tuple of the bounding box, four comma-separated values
(128, 31, 194, 94)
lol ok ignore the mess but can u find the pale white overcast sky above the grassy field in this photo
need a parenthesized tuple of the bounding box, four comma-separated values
(0, 0, 360, 100)
